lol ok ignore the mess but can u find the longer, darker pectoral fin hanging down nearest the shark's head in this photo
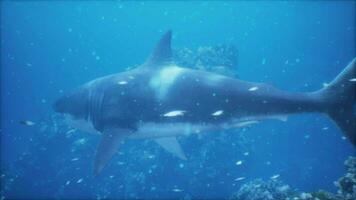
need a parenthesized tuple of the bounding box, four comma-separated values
(94, 129, 127, 175)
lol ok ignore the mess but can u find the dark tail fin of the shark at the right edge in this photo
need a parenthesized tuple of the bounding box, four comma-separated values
(316, 58, 356, 146)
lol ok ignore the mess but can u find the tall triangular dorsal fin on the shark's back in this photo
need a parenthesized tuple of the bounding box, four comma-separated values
(143, 30, 172, 67)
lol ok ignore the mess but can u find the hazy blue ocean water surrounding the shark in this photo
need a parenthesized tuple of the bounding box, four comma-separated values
(1, 1, 356, 199)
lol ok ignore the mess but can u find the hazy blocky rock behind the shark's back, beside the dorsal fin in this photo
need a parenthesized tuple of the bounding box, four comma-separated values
(173, 45, 238, 77)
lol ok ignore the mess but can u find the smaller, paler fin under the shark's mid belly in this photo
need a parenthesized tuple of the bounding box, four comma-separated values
(155, 137, 187, 160)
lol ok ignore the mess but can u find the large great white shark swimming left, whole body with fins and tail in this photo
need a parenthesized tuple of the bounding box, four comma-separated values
(53, 31, 356, 174)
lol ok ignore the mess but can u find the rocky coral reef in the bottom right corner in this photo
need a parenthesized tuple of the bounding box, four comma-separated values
(230, 157, 356, 200)
